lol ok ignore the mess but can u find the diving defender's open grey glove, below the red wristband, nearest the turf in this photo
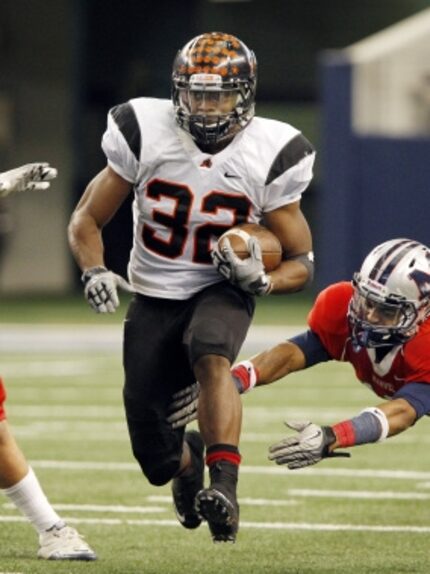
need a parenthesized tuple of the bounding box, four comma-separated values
(269, 422, 351, 469)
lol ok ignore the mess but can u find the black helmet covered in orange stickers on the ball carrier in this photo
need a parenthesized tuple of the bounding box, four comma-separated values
(172, 32, 257, 145)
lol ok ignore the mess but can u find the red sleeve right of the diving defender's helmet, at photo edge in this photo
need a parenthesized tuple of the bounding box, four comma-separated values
(404, 319, 430, 383)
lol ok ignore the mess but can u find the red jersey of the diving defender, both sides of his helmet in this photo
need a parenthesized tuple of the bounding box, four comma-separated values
(308, 282, 430, 398)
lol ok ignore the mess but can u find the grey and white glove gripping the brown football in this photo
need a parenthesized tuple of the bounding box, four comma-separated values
(211, 237, 272, 295)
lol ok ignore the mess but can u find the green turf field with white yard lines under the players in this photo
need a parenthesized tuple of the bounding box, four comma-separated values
(0, 297, 430, 574)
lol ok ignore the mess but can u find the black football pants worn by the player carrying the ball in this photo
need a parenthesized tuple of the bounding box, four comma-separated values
(123, 281, 255, 485)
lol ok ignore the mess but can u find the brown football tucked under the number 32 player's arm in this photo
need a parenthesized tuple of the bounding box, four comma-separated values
(218, 223, 282, 272)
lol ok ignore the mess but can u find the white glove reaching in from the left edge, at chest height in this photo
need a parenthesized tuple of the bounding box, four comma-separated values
(0, 163, 57, 197)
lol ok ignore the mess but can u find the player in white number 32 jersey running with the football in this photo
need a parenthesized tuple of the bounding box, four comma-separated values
(69, 32, 315, 542)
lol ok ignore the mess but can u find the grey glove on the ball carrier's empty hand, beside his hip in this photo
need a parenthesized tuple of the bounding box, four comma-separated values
(81, 266, 133, 313)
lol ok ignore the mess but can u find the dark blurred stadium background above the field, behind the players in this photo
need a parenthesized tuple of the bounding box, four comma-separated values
(0, 0, 430, 296)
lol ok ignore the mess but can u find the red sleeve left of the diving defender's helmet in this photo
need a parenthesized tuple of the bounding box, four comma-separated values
(308, 282, 353, 360)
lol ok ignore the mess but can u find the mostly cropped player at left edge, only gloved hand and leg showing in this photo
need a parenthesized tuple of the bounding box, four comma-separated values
(0, 162, 97, 560)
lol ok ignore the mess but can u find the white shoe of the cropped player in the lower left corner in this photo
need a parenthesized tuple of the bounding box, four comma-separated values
(37, 525, 97, 561)
